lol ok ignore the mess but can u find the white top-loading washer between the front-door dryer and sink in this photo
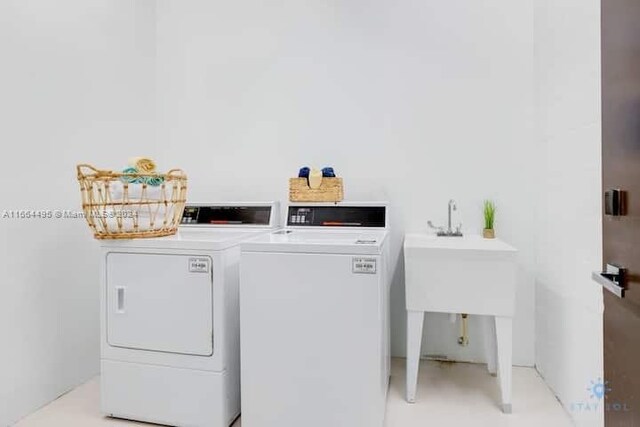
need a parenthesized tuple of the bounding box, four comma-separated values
(240, 203, 390, 427)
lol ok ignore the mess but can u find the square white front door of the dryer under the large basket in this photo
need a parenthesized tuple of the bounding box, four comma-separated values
(106, 253, 213, 356)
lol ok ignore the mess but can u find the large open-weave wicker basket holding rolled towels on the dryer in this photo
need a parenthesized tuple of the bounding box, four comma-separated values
(77, 164, 187, 239)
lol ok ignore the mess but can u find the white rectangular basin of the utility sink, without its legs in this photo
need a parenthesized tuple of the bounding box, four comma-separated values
(404, 234, 517, 316)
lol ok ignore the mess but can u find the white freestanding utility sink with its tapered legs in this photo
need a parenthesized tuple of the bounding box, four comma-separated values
(404, 234, 517, 413)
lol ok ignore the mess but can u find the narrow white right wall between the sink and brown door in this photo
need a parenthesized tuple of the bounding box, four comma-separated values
(535, 0, 603, 426)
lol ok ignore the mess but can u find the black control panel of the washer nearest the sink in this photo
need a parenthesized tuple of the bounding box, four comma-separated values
(287, 206, 387, 228)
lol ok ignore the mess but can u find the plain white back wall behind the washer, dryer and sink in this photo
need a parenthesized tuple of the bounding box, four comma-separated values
(154, 0, 536, 365)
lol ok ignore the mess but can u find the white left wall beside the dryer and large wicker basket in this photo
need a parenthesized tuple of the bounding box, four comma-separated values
(0, 0, 155, 426)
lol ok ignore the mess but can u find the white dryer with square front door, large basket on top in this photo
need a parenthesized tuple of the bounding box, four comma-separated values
(101, 203, 278, 427)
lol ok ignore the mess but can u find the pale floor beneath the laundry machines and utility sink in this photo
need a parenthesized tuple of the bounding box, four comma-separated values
(16, 359, 573, 427)
